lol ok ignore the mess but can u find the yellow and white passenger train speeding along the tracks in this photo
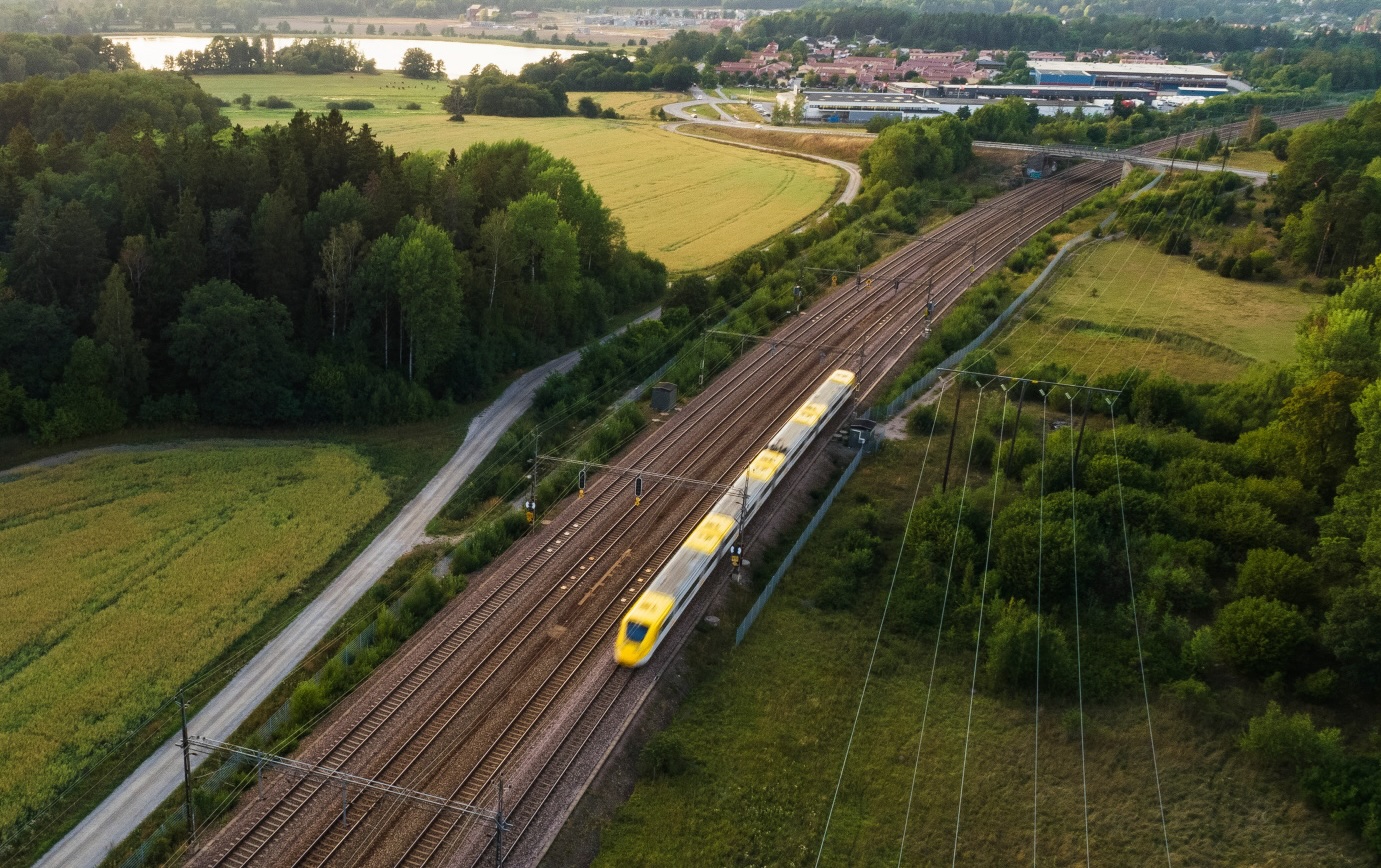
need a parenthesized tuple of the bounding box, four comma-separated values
(613, 368, 855, 667)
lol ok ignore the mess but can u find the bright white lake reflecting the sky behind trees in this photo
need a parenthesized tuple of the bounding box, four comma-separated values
(109, 33, 576, 77)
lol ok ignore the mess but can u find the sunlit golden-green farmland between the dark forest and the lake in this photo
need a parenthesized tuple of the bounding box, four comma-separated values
(197, 73, 841, 270)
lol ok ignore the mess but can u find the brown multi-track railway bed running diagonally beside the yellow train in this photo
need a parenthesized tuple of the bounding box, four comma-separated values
(192, 110, 1327, 865)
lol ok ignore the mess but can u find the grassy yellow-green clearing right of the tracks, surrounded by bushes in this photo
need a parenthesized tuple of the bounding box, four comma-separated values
(989, 240, 1317, 382)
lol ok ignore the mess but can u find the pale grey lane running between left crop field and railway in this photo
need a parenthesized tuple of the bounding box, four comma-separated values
(36, 308, 661, 868)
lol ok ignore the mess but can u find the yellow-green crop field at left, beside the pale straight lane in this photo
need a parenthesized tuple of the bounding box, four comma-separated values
(0, 444, 388, 829)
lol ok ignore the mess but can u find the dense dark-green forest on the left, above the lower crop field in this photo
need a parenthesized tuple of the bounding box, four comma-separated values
(0, 64, 666, 442)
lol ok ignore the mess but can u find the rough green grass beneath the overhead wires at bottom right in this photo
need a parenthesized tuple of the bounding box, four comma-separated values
(591, 432, 1371, 868)
